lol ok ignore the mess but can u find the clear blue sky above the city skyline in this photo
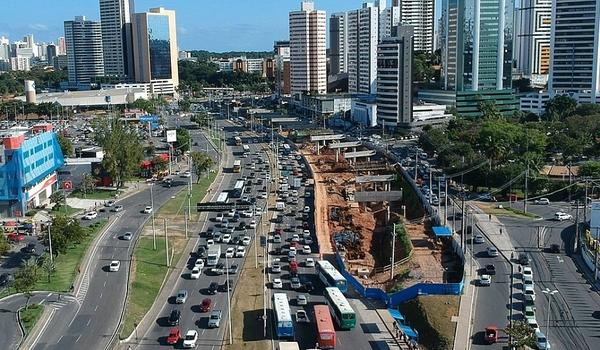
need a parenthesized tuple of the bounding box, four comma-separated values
(0, 0, 380, 52)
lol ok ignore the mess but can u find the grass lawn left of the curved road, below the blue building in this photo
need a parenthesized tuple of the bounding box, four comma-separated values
(34, 219, 107, 292)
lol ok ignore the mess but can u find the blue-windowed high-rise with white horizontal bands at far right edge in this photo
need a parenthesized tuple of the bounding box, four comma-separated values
(548, 0, 600, 103)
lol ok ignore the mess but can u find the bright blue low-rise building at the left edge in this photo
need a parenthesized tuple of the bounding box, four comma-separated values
(0, 124, 64, 217)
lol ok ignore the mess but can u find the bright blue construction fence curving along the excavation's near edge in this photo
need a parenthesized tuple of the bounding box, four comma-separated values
(335, 252, 464, 307)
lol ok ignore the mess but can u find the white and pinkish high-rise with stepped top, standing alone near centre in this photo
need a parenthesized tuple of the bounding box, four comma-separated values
(289, 1, 327, 95)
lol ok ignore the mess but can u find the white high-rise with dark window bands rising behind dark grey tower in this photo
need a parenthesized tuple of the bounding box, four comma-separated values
(392, 0, 435, 52)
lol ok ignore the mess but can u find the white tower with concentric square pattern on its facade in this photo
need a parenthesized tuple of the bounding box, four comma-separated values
(514, 0, 552, 80)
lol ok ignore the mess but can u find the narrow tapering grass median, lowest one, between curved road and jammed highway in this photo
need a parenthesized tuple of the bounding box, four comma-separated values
(120, 236, 186, 339)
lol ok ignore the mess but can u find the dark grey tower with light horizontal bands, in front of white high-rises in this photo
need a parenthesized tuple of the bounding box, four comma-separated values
(377, 26, 414, 129)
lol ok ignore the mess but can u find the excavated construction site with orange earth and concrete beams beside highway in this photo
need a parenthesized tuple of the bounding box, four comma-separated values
(299, 135, 456, 292)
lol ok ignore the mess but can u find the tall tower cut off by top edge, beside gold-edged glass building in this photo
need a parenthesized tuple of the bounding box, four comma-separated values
(100, 0, 134, 80)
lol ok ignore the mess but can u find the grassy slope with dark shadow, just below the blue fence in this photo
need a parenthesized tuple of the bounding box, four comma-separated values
(400, 295, 460, 349)
